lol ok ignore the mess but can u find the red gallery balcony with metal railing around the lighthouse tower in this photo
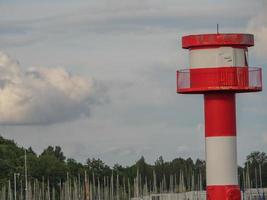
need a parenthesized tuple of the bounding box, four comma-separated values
(177, 67, 262, 93)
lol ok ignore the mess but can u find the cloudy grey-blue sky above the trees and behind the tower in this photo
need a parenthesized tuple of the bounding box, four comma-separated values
(0, 0, 267, 166)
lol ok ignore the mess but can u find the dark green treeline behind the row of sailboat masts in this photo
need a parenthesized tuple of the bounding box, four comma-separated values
(0, 136, 267, 190)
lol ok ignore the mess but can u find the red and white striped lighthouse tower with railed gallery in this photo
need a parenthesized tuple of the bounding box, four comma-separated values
(177, 34, 262, 200)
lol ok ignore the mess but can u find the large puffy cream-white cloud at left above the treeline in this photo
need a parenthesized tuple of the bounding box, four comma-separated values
(0, 52, 105, 125)
